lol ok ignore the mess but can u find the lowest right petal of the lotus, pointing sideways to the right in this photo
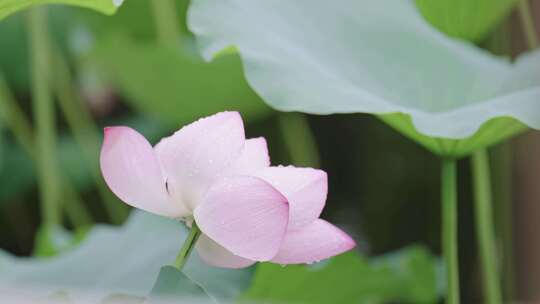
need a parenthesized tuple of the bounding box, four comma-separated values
(272, 219, 356, 264)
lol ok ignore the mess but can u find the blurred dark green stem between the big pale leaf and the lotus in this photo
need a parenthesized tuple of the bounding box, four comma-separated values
(278, 113, 320, 168)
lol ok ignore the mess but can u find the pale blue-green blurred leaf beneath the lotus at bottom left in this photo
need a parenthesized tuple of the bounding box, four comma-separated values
(0, 212, 252, 303)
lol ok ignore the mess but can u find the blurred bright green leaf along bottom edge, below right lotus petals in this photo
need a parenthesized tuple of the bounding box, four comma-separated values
(243, 247, 440, 304)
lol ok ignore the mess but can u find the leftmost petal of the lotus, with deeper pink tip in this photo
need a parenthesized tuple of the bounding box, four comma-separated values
(100, 127, 186, 217)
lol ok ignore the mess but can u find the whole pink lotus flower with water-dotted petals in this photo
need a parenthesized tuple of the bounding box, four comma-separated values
(100, 112, 355, 268)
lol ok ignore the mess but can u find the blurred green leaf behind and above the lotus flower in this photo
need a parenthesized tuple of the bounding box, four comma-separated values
(90, 35, 270, 125)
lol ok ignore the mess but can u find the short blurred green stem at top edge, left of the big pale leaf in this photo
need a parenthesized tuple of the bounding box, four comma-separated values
(150, 0, 180, 47)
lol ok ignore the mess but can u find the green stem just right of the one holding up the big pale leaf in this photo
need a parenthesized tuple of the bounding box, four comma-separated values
(472, 149, 502, 304)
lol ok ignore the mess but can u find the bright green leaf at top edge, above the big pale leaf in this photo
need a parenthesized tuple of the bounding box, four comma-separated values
(416, 0, 517, 42)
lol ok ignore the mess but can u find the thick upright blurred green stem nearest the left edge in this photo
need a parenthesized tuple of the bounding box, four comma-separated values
(28, 7, 60, 227)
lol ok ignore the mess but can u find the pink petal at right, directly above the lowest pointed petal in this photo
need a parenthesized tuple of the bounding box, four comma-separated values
(255, 166, 328, 230)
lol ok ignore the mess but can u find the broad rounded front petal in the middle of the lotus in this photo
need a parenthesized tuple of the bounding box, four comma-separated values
(194, 176, 289, 261)
